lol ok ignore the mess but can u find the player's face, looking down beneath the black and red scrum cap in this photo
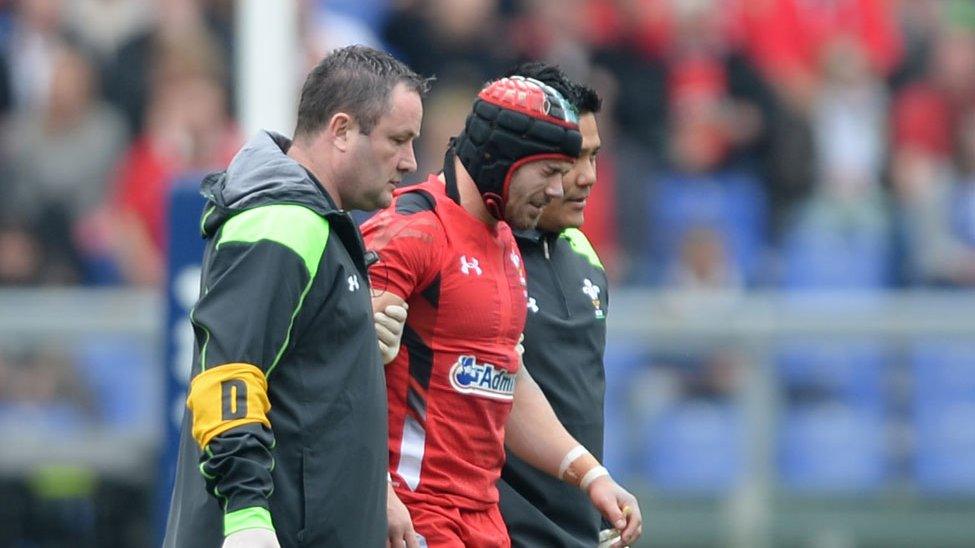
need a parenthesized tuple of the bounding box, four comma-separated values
(504, 160, 572, 229)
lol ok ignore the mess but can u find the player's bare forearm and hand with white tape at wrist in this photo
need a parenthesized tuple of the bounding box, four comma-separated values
(505, 366, 643, 544)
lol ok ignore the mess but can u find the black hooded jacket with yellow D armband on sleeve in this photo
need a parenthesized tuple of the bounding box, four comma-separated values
(164, 132, 388, 548)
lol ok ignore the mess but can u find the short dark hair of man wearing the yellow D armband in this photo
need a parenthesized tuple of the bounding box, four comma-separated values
(295, 45, 431, 138)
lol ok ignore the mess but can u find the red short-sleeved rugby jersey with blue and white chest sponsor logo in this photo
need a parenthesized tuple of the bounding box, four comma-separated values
(362, 175, 527, 510)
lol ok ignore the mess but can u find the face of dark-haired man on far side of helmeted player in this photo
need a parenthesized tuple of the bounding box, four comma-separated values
(538, 112, 602, 232)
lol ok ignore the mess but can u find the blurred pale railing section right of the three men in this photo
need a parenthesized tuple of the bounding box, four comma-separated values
(607, 290, 975, 548)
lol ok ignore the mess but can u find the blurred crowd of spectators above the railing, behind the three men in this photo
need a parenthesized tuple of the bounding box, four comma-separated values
(0, 0, 975, 292)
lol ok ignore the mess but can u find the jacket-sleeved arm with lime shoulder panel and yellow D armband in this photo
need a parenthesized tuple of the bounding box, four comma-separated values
(187, 205, 329, 546)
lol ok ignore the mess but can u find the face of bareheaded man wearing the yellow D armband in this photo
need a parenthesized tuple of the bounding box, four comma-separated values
(342, 83, 423, 211)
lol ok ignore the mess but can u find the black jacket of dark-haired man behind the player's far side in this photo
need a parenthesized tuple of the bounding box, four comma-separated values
(498, 229, 609, 548)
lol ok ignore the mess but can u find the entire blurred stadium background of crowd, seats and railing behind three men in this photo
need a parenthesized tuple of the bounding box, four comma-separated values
(0, 0, 975, 548)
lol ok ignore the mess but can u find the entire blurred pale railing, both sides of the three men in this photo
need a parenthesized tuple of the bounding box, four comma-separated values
(0, 289, 975, 548)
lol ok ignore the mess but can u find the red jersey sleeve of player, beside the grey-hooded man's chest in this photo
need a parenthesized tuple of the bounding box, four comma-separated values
(362, 210, 444, 300)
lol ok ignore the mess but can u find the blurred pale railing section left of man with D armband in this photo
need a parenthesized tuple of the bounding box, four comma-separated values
(0, 289, 165, 481)
